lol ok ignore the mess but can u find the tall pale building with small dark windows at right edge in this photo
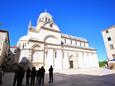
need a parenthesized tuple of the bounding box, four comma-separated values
(102, 26, 115, 69)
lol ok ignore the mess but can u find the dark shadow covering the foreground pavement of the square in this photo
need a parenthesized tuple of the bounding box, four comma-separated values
(1, 73, 115, 86)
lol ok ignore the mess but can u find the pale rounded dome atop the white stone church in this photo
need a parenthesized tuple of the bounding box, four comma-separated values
(37, 11, 53, 24)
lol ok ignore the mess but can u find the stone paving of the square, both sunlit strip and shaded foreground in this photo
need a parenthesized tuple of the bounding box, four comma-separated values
(1, 69, 115, 86)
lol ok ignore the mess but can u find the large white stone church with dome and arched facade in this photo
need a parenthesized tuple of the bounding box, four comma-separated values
(17, 12, 99, 69)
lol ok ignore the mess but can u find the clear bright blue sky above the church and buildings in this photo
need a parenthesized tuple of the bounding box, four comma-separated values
(0, 0, 115, 61)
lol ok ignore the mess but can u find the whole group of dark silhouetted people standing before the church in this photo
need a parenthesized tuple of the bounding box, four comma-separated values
(13, 66, 53, 86)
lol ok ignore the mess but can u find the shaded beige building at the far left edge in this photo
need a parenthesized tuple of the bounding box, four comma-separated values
(0, 30, 10, 66)
